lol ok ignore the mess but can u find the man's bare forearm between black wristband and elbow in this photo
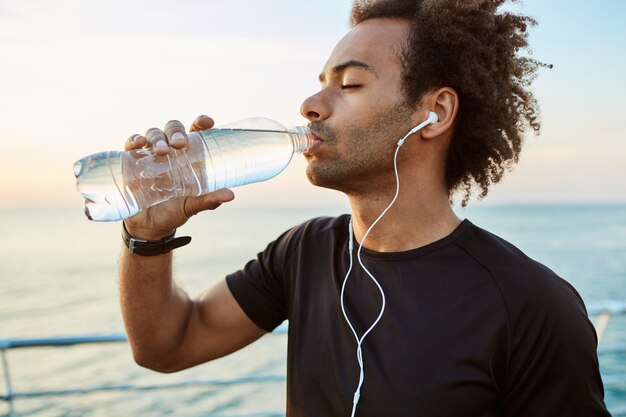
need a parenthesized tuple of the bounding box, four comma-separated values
(119, 248, 193, 370)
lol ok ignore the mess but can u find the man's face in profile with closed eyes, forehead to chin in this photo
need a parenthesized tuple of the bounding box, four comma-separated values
(301, 19, 415, 193)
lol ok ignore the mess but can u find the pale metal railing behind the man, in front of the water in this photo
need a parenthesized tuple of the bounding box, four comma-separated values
(0, 301, 626, 417)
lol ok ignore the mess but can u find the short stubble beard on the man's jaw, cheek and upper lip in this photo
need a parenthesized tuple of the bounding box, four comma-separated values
(306, 101, 413, 194)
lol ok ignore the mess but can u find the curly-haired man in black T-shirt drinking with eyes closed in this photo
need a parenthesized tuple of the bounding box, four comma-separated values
(120, 0, 609, 417)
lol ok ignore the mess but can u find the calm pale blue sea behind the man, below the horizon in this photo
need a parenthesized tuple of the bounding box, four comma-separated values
(0, 203, 626, 417)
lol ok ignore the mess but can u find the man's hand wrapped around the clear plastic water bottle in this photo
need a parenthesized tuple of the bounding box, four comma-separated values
(124, 116, 235, 240)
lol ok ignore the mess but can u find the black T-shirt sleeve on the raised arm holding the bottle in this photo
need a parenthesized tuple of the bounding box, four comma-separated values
(226, 229, 294, 332)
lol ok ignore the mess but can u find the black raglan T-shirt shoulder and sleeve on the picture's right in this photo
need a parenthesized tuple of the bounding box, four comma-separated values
(455, 225, 605, 410)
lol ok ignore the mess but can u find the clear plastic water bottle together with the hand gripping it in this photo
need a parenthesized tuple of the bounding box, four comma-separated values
(74, 116, 313, 228)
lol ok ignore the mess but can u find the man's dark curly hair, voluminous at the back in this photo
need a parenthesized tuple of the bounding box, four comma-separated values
(350, 0, 551, 206)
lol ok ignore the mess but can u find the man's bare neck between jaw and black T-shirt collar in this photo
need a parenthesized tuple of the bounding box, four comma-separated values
(348, 183, 461, 252)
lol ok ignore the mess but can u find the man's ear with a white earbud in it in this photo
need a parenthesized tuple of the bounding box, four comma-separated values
(420, 87, 459, 139)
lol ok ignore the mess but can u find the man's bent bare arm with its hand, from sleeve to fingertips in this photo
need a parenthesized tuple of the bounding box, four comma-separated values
(120, 115, 265, 372)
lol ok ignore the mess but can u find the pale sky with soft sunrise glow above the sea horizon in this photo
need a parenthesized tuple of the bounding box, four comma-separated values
(0, 0, 626, 207)
